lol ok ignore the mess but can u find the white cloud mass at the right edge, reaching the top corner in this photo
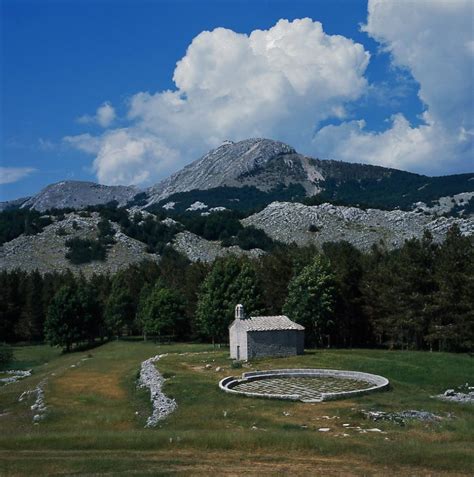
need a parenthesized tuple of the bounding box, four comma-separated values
(314, 0, 474, 173)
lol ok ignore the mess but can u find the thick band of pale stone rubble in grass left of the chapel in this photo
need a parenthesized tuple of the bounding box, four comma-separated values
(138, 354, 178, 427)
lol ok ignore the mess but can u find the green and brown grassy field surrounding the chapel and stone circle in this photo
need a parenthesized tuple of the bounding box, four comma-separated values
(0, 342, 474, 476)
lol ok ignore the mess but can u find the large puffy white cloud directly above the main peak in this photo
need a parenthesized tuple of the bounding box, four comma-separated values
(66, 18, 370, 184)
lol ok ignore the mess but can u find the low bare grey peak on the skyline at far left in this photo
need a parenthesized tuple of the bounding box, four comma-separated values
(21, 181, 140, 212)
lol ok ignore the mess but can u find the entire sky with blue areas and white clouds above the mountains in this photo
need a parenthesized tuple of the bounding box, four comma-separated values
(0, 0, 474, 200)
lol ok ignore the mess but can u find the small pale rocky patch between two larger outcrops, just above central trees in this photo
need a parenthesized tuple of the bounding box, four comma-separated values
(173, 231, 265, 262)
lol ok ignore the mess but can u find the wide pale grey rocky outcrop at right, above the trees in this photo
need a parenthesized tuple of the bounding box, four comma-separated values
(242, 202, 474, 250)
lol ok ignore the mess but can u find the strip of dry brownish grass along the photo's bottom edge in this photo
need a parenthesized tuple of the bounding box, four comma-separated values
(0, 449, 467, 477)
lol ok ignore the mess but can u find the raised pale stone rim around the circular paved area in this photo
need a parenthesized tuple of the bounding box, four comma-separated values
(219, 368, 390, 402)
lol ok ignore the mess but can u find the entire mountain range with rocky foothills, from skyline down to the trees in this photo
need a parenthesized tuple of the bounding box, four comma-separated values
(0, 139, 474, 275)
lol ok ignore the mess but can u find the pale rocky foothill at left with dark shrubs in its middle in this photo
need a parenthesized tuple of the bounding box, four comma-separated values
(0, 213, 159, 276)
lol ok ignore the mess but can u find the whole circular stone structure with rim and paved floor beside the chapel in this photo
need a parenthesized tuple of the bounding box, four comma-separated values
(219, 369, 389, 402)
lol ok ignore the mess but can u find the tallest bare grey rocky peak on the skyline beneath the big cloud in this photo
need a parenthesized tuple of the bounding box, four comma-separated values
(147, 138, 422, 203)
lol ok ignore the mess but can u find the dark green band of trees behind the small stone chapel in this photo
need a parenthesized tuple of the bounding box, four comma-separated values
(0, 227, 474, 352)
